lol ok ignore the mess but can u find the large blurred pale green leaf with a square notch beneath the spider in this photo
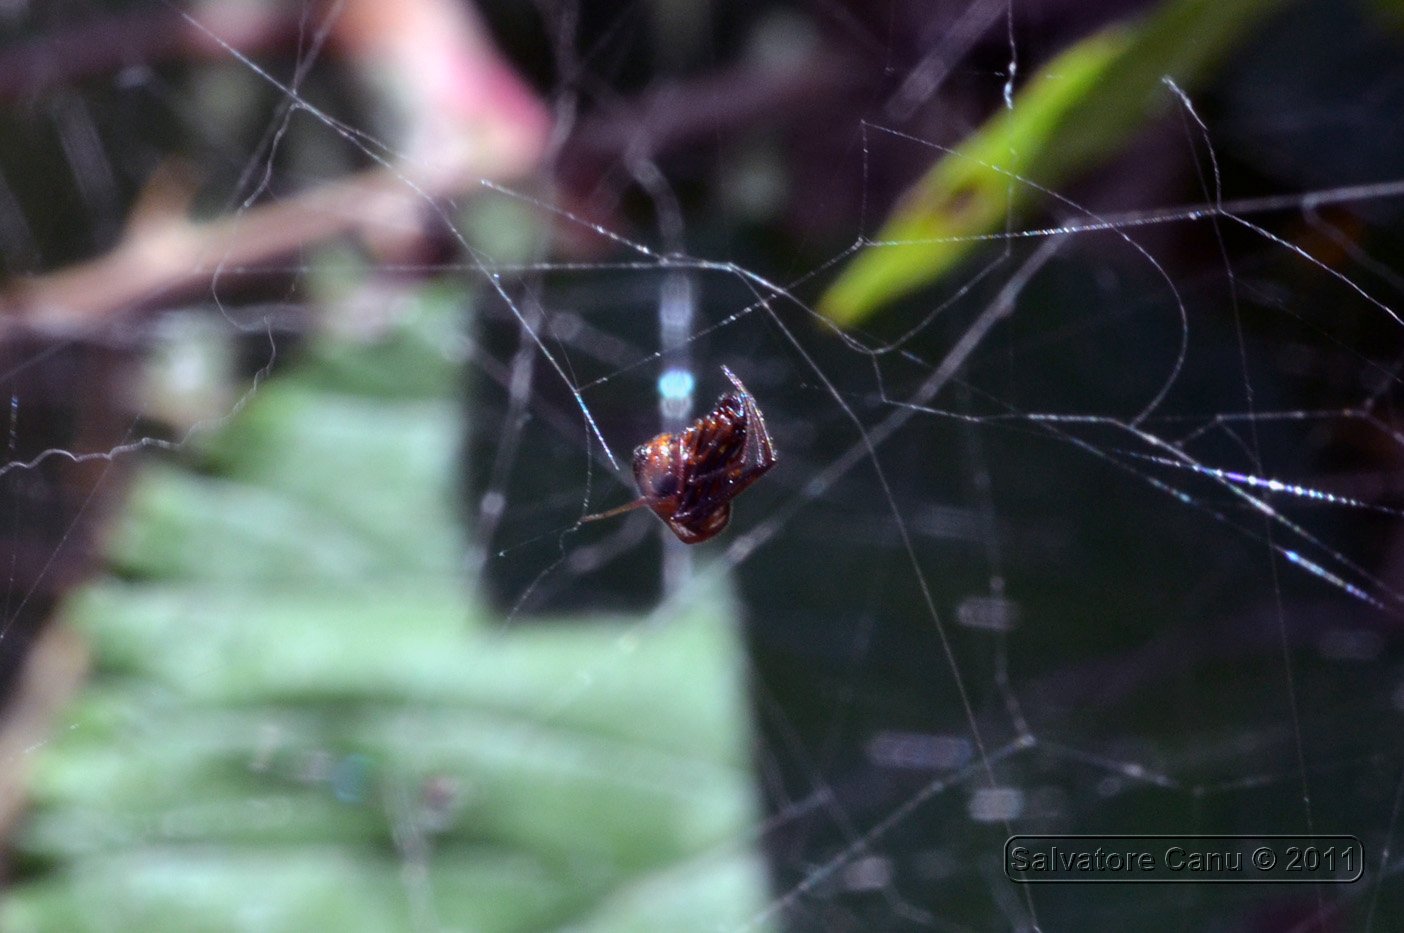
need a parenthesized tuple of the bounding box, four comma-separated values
(0, 288, 765, 932)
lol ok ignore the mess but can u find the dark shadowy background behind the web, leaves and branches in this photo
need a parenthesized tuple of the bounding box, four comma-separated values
(0, 0, 1404, 930)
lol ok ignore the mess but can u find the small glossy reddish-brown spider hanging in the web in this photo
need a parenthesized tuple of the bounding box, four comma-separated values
(581, 366, 775, 544)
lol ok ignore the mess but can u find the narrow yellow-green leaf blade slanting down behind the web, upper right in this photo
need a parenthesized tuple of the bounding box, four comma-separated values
(819, 0, 1286, 327)
